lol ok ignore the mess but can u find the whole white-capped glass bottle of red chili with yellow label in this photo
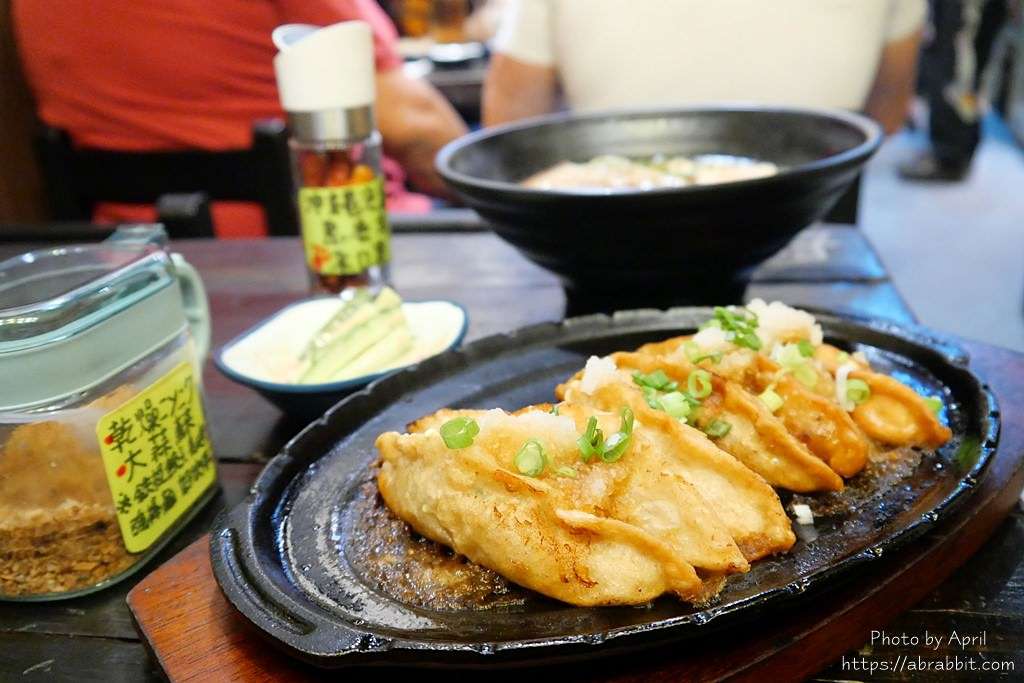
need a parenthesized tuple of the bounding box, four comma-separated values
(273, 22, 391, 294)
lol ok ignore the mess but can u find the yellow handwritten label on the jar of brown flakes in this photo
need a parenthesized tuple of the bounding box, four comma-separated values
(96, 361, 217, 553)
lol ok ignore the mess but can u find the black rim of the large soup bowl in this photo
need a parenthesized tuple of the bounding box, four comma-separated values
(434, 101, 885, 199)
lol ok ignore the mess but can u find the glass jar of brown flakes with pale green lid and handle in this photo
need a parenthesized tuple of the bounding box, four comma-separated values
(0, 226, 217, 601)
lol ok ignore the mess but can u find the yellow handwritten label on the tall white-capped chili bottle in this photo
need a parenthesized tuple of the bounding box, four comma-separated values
(299, 178, 391, 275)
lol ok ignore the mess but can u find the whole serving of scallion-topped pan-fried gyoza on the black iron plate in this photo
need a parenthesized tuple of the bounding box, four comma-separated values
(377, 301, 950, 605)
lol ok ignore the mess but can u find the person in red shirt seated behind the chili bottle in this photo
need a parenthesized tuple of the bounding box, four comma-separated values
(11, 0, 466, 237)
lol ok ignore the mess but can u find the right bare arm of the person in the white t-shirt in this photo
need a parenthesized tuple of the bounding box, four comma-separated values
(864, 31, 921, 133)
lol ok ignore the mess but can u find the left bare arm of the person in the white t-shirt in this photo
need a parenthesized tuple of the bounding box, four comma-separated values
(483, 54, 558, 126)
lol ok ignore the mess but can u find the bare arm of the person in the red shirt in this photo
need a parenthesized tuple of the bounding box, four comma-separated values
(376, 69, 466, 197)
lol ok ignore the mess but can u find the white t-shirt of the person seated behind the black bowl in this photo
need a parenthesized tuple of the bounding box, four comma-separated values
(494, 0, 927, 110)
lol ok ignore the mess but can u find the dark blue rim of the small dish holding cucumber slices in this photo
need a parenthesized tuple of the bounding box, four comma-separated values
(213, 296, 469, 395)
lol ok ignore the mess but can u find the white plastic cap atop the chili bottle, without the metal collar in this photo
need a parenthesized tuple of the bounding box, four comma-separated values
(272, 22, 375, 113)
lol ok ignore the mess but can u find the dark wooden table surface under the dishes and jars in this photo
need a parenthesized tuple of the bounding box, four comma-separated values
(0, 227, 1024, 681)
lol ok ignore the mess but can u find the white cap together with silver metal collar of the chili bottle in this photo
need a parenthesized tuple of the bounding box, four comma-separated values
(272, 22, 376, 142)
